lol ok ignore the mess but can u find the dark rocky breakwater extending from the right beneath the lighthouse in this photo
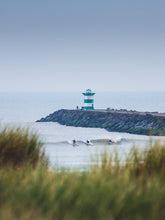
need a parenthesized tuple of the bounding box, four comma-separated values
(37, 109, 165, 135)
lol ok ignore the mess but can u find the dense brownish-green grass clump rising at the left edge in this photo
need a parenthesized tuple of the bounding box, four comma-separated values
(0, 127, 48, 168)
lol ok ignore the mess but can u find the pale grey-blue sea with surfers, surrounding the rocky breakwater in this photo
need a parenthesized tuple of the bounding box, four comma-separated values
(0, 92, 165, 170)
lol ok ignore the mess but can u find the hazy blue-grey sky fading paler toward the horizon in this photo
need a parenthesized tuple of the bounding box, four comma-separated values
(0, 0, 165, 91)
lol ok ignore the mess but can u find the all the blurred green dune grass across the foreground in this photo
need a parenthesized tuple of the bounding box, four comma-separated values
(0, 126, 165, 220)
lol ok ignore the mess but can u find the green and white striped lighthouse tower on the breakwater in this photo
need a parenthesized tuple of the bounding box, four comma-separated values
(82, 89, 95, 110)
